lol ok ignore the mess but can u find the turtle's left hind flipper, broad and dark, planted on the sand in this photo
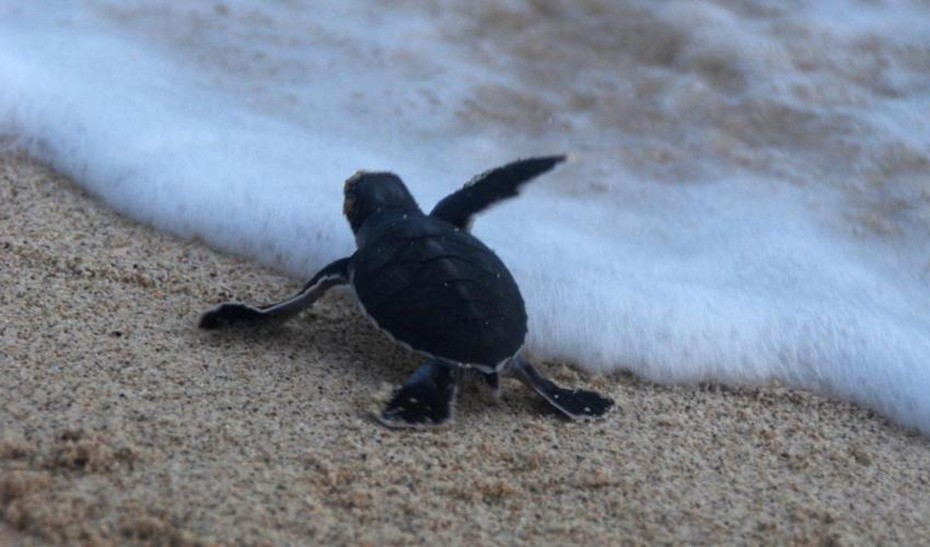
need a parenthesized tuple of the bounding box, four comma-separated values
(378, 360, 455, 427)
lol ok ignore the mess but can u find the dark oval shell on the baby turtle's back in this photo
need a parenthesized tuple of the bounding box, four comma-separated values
(351, 213, 526, 368)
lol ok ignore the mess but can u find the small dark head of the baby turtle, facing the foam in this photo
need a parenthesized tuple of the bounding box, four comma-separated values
(342, 171, 420, 233)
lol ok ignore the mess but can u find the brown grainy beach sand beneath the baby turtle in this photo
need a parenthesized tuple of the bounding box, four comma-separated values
(0, 152, 930, 544)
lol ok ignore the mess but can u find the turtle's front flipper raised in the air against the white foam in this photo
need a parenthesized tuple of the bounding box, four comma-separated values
(430, 156, 565, 230)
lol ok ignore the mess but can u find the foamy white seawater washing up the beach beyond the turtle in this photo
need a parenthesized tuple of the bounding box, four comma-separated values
(0, 0, 930, 433)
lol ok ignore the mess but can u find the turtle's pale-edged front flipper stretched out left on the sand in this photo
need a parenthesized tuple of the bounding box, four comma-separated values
(199, 258, 349, 330)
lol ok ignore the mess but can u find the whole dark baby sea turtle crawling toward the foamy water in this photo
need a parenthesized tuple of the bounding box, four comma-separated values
(200, 156, 614, 427)
